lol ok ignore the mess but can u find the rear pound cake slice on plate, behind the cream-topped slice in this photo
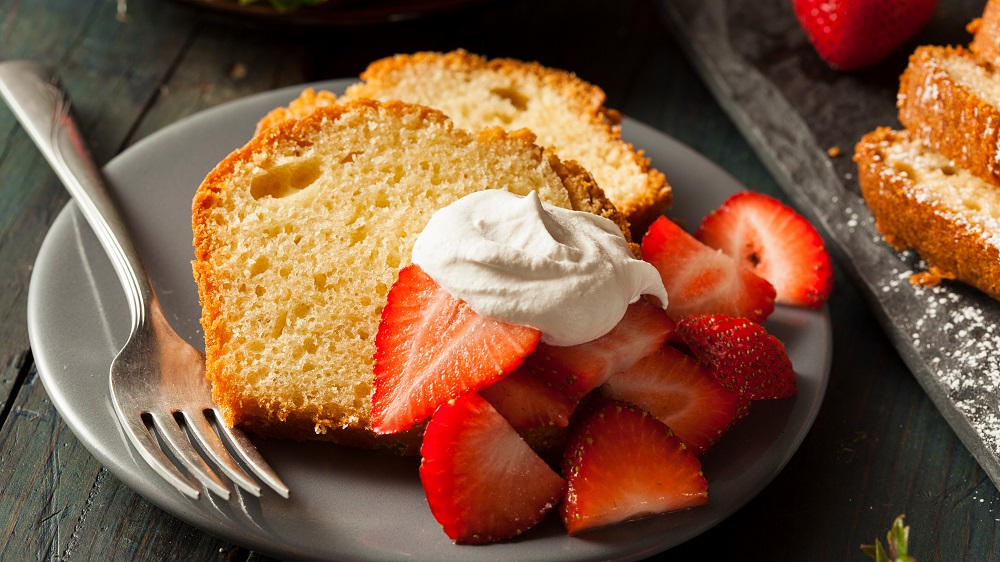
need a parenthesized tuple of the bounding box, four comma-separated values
(264, 50, 671, 239)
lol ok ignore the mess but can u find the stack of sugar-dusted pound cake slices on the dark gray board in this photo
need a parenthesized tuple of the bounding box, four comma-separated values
(854, 0, 1000, 300)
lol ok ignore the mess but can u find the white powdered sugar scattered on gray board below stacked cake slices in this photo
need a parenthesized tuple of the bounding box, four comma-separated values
(829, 179, 1000, 464)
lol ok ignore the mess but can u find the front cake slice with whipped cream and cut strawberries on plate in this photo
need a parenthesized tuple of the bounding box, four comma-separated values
(192, 53, 832, 544)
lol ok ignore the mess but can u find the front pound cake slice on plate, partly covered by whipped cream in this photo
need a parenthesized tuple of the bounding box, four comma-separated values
(192, 96, 627, 446)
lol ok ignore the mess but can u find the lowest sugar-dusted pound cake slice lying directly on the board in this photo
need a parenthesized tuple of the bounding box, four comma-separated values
(854, 127, 1000, 299)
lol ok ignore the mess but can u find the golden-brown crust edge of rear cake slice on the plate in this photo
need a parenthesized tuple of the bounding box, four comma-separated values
(348, 49, 673, 239)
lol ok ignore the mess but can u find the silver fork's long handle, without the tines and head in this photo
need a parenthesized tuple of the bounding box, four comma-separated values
(0, 61, 153, 332)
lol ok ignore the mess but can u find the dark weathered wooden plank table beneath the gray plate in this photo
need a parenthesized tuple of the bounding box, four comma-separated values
(0, 0, 1000, 562)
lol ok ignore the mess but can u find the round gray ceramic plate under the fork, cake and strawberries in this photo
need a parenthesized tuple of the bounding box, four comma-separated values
(28, 81, 831, 561)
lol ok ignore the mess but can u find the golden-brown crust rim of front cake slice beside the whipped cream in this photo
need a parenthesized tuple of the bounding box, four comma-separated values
(192, 99, 637, 453)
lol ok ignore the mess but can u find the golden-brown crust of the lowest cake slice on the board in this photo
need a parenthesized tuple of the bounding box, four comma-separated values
(854, 127, 1000, 299)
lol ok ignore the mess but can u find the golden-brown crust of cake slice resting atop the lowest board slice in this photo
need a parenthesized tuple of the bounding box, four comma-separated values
(897, 46, 1000, 185)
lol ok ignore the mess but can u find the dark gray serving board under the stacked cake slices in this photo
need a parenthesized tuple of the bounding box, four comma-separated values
(661, 0, 1000, 487)
